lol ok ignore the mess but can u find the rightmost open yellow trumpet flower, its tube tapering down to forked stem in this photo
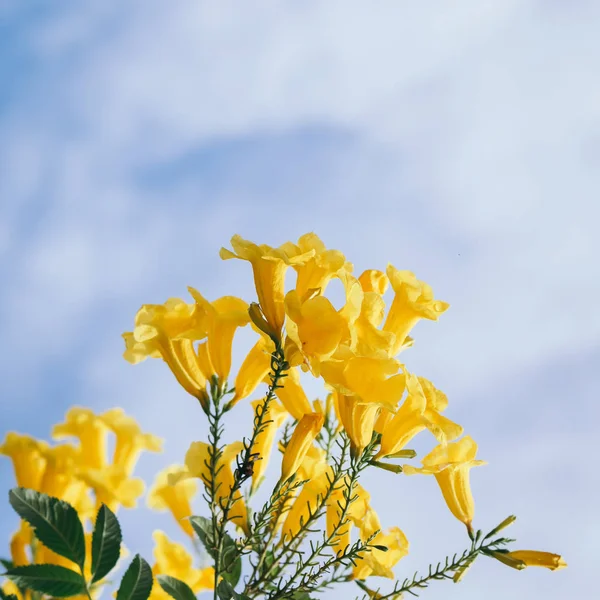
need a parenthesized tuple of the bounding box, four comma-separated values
(403, 435, 486, 531)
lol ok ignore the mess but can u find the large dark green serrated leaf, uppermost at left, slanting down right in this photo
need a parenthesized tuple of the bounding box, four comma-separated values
(8, 488, 85, 567)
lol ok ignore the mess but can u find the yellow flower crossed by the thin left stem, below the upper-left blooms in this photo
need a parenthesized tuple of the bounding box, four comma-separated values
(173, 442, 248, 534)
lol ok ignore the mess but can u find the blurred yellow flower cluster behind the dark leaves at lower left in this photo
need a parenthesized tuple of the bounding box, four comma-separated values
(0, 407, 162, 593)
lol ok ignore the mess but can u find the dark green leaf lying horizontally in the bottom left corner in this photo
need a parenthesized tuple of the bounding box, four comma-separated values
(6, 565, 85, 598)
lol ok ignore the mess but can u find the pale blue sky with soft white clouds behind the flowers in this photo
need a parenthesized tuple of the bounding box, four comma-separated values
(0, 0, 600, 600)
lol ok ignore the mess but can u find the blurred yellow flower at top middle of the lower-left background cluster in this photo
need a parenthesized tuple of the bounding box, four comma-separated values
(52, 406, 108, 469)
